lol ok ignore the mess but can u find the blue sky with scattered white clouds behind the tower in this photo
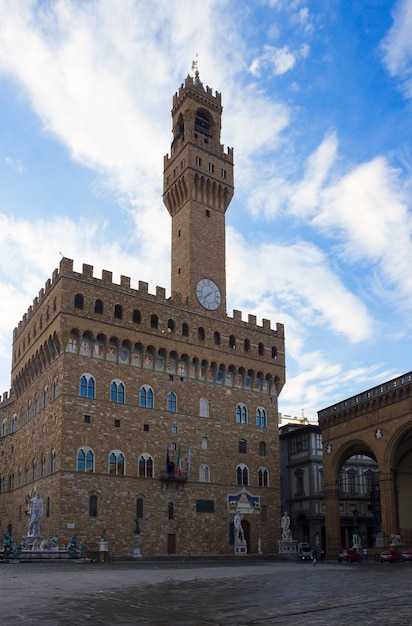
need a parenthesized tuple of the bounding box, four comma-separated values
(0, 0, 412, 418)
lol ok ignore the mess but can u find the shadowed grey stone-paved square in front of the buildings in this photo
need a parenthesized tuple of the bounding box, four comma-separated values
(0, 558, 412, 626)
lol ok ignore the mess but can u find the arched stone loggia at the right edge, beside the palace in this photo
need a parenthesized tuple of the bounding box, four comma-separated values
(318, 373, 412, 553)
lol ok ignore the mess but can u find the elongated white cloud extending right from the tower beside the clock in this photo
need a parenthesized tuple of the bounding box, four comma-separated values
(228, 229, 374, 342)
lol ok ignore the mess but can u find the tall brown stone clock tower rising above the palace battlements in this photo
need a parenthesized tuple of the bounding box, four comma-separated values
(163, 63, 233, 316)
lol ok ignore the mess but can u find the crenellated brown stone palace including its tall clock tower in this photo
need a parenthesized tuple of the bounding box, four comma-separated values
(0, 72, 285, 556)
